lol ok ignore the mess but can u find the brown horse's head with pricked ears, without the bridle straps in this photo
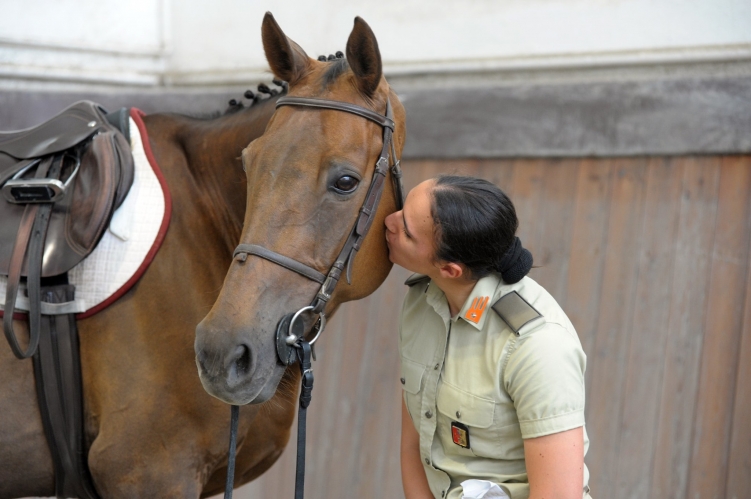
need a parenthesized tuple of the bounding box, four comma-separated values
(195, 13, 405, 405)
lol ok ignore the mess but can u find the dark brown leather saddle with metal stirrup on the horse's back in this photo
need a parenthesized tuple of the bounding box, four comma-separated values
(0, 101, 134, 358)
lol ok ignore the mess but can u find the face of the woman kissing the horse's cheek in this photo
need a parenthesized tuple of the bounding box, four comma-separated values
(385, 180, 437, 275)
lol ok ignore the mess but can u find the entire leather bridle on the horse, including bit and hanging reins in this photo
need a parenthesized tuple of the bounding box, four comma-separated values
(224, 92, 404, 499)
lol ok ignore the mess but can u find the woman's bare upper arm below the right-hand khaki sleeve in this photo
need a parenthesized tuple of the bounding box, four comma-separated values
(524, 427, 584, 499)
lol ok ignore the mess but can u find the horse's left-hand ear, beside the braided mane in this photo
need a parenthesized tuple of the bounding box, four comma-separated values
(261, 12, 310, 85)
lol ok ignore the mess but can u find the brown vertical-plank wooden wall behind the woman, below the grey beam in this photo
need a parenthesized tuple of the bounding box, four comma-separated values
(223, 156, 751, 499)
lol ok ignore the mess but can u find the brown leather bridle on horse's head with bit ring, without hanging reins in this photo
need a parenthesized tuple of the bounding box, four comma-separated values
(233, 96, 404, 365)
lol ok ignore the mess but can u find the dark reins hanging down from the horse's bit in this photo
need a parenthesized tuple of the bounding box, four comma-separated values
(224, 339, 313, 499)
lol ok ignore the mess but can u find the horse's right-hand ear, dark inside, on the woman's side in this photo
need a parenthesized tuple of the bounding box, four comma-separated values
(347, 17, 382, 97)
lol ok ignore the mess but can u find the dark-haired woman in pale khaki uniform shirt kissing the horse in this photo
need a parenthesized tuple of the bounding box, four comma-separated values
(385, 176, 589, 499)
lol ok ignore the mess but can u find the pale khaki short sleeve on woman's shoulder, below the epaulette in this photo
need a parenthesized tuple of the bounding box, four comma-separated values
(501, 323, 586, 438)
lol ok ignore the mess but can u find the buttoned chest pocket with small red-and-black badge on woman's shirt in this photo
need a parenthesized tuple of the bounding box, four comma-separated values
(436, 382, 524, 459)
